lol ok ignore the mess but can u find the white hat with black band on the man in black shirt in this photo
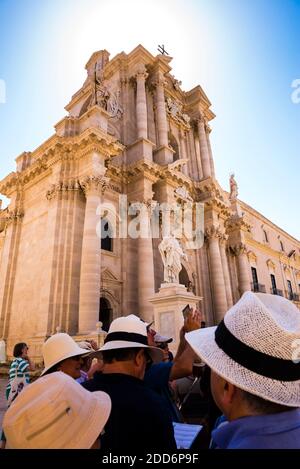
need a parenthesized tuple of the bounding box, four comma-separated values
(100, 314, 163, 363)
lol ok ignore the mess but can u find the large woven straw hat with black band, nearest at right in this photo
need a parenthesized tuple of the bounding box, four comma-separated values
(185, 292, 300, 407)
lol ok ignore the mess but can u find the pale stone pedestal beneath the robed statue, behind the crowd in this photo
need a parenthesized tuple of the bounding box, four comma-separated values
(149, 283, 202, 353)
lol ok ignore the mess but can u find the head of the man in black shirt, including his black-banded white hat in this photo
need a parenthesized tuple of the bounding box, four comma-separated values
(101, 314, 163, 379)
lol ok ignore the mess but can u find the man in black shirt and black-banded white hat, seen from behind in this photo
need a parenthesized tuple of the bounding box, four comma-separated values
(82, 315, 176, 454)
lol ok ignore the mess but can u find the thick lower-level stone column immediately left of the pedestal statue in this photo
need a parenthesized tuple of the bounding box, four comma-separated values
(137, 200, 155, 322)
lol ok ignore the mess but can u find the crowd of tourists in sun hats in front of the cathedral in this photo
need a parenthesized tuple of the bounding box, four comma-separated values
(2, 292, 300, 454)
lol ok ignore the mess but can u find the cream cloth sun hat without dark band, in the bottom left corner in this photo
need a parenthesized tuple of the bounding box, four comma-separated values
(3, 371, 111, 449)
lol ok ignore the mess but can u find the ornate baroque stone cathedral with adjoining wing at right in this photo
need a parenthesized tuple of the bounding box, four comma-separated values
(0, 46, 300, 357)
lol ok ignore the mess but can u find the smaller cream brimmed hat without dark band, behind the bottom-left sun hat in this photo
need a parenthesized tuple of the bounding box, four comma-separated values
(41, 332, 89, 376)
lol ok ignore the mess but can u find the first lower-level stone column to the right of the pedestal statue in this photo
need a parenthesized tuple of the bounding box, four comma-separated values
(205, 226, 227, 322)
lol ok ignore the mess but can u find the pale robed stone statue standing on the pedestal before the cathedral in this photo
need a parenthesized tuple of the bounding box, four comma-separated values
(158, 235, 188, 283)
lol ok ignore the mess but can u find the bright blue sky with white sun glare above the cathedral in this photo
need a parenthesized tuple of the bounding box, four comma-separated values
(0, 0, 300, 239)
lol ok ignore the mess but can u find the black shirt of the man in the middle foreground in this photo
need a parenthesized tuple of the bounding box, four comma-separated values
(82, 373, 176, 454)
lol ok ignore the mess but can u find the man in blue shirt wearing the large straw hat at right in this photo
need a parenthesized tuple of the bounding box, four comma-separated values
(186, 292, 300, 449)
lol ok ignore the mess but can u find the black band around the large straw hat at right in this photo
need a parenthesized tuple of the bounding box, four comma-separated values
(215, 320, 300, 381)
